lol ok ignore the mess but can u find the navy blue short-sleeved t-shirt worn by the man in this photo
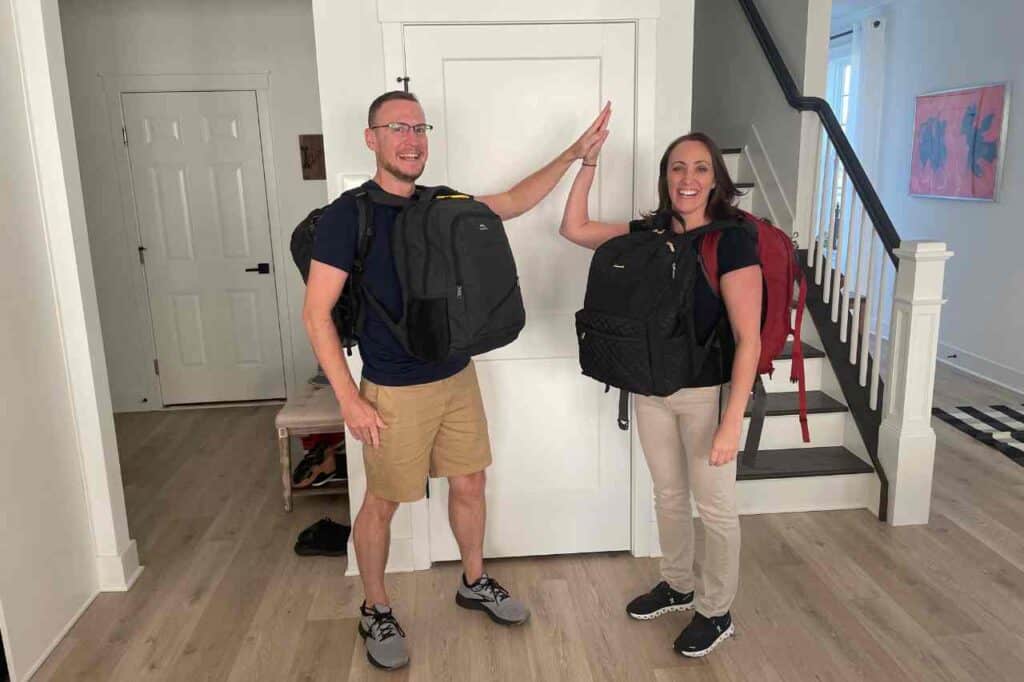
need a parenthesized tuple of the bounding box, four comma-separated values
(313, 180, 469, 386)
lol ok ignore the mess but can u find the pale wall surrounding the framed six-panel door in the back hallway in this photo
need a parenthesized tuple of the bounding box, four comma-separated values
(60, 0, 327, 412)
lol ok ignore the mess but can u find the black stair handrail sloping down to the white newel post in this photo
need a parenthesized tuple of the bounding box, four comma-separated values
(737, 0, 900, 268)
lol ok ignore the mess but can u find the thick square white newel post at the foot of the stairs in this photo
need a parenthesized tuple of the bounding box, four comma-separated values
(879, 242, 952, 525)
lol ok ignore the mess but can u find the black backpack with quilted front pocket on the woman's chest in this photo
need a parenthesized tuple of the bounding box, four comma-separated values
(575, 223, 732, 429)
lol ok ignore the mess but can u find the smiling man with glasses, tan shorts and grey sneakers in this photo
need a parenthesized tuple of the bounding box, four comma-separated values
(303, 91, 609, 669)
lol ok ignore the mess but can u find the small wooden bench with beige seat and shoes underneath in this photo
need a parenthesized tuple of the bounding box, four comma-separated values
(273, 386, 348, 511)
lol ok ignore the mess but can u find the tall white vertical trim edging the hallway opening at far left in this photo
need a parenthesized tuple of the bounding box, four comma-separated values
(11, 0, 132, 593)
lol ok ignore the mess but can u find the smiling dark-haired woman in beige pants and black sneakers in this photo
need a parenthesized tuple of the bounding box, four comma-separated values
(559, 115, 762, 656)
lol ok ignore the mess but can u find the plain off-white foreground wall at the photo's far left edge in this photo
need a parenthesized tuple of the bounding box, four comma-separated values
(0, 2, 98, 680)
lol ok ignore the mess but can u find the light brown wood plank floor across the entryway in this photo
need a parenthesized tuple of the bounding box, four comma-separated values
(28, 369, 1024, 682)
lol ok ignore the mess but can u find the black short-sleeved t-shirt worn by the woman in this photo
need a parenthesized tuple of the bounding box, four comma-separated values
(630, 217, 761, 388)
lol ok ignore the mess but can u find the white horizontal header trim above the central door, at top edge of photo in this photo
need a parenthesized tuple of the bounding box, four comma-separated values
(377, 0, 655, 22)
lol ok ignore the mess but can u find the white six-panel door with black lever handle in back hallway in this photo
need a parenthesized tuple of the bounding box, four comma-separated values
(122, 91, 285, 404)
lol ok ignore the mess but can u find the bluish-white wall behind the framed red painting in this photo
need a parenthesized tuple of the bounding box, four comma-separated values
(878, 0, 1024, 391)
